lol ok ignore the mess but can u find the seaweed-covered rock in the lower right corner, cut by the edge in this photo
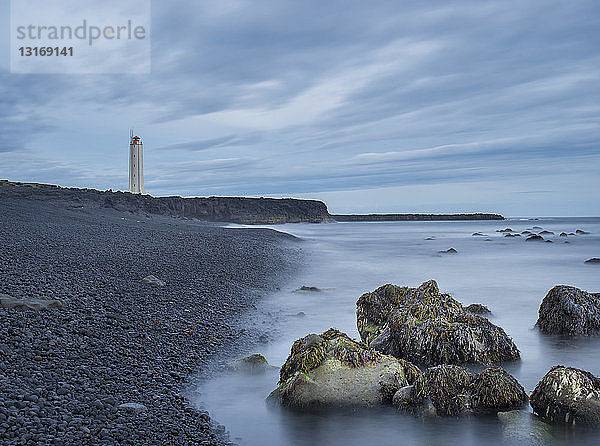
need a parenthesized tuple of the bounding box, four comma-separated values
(530, 365, 600, 425)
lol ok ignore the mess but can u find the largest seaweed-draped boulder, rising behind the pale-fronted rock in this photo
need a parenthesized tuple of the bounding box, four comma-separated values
(356, 280, 520, 365)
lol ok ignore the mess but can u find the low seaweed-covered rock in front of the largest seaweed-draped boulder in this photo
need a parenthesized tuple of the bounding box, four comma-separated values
(393, 365, 527, 416)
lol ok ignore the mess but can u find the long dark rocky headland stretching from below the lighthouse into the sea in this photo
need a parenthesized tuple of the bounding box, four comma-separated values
(0, 180, 504, 224)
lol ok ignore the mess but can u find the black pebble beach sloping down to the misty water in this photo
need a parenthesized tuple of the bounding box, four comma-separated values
(0, 198, 300, 444)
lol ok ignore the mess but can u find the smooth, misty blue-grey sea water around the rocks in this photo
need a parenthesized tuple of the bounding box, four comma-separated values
(191, 218, 600, 446)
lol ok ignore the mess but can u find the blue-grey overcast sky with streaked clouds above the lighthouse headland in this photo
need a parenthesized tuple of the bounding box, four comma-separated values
(0, 0, 600, 216)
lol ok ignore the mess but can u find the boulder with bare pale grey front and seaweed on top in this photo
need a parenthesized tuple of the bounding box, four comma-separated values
(268, 328, 421, 408)
